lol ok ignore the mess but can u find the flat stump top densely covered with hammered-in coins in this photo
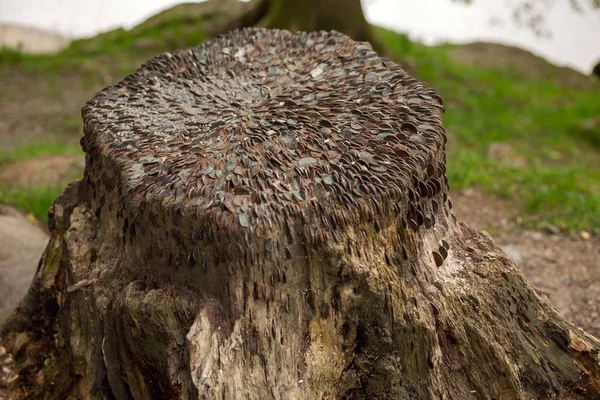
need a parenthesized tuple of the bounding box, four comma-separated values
(82, 29, 449, 268)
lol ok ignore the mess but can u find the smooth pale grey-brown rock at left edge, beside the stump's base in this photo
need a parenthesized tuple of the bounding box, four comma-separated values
(0, 204, 48, 323)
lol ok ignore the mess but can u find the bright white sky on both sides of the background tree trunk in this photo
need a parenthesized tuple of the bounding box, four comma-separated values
(0, 0, 600, 73)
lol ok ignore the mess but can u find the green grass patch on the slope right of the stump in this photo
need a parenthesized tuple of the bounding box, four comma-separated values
(377, 29, 600, 234)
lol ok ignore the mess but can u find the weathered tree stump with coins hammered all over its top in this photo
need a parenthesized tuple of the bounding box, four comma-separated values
(0, 29, 600, 399)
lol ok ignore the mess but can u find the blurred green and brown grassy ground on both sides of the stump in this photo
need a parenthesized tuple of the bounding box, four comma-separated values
(0, 17, 600, 234)
